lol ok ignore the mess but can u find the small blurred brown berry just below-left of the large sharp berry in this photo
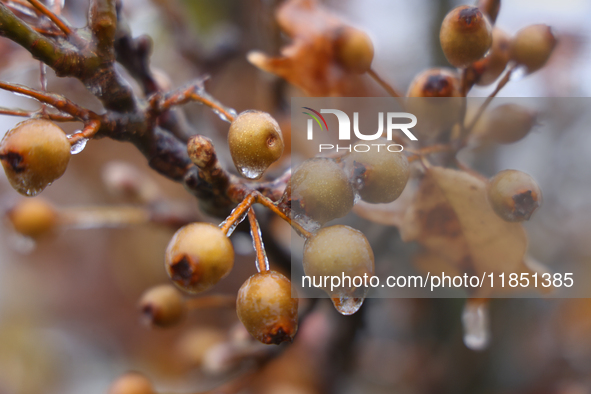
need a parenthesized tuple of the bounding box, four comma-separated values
(139, 285, 186, 328)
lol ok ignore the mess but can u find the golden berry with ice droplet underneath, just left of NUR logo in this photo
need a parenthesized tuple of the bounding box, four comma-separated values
(228, 111, 283, 179)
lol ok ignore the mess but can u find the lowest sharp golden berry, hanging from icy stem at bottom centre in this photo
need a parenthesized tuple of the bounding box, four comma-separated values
(236, 271, 298, 345)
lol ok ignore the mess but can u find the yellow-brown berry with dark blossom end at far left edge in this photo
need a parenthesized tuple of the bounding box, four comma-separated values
(0, 119, 70, 196)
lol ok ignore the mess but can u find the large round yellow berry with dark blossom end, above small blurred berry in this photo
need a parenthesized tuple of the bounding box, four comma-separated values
(165, 223, 234, 293)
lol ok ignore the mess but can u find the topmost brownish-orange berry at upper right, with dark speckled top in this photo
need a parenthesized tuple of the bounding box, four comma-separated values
(439, 5, 492, 67)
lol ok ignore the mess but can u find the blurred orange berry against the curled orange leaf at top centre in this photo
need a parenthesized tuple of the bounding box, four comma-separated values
(334, 26, 373, 74)
